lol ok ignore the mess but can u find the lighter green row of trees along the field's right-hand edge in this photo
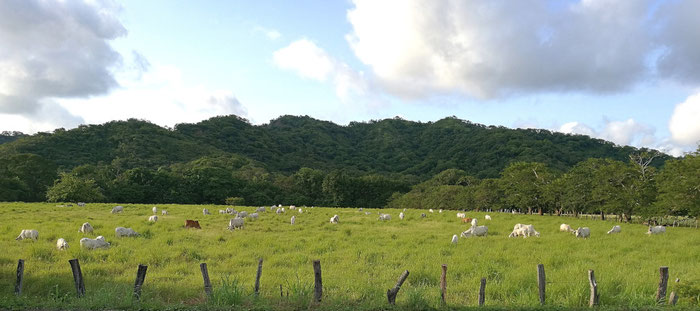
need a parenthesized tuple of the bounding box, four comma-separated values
(388, 148, 700, 221)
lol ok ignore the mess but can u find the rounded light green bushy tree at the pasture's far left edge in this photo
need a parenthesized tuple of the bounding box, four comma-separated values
(46, 173, 105, 202)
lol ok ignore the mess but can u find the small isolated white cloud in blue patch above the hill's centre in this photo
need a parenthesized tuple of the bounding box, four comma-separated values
(273, 39, 367, 100)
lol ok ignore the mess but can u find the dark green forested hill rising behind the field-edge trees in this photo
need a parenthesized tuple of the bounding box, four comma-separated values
(0, 115, 666, 178)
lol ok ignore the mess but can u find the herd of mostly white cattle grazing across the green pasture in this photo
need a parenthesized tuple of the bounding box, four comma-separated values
(16, 203, 666, 250)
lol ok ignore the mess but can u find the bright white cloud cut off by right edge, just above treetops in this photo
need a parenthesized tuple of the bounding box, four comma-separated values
(668, 93, 700, 146)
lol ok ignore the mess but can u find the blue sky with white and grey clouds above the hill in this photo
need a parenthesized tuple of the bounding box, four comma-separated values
(0, 0, 700, 155)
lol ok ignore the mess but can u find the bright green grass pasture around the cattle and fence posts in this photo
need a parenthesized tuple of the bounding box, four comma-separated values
(0, 203, 700, 310)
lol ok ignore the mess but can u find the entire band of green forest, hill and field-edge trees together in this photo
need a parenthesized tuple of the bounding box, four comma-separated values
(0, 115, 700, 222)
